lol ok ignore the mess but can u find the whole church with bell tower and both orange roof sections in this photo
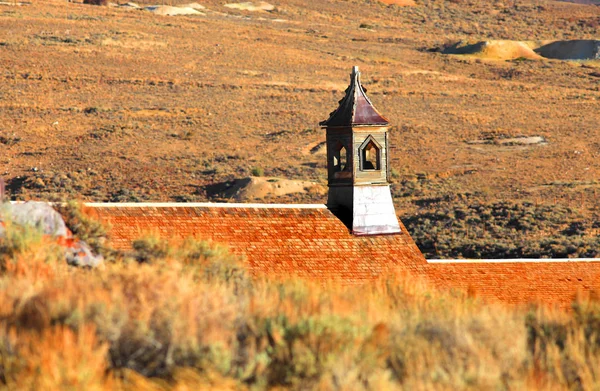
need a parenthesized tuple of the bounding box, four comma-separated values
(70, 67, 600, 308)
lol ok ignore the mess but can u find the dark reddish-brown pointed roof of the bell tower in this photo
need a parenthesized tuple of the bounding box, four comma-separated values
(319, 66, 389, 127)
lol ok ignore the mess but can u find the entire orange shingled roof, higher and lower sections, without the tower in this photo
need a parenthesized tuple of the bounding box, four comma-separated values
(79, 204, 600, 308)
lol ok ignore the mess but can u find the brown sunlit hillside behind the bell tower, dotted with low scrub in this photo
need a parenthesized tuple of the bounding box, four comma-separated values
(0, 0, 600, 227)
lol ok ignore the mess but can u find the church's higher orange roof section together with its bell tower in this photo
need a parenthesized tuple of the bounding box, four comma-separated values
(86, 67, 427, 283)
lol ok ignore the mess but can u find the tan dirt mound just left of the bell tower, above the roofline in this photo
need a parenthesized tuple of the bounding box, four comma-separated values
(206, 177, 322, 201)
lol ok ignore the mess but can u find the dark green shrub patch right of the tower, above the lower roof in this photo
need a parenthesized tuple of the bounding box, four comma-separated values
(403, 202, 600, 258)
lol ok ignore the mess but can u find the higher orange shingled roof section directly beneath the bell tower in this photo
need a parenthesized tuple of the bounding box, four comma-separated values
(87, 204, 426, 283)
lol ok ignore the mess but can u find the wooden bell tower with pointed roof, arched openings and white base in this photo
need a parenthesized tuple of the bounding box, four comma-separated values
(319, 66, 400, 235)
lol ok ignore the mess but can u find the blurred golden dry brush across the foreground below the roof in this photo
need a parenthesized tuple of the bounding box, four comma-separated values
(0, 220, 600, 390)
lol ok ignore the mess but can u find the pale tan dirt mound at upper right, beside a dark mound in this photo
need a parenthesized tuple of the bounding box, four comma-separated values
(442, 41, 542, 60)
